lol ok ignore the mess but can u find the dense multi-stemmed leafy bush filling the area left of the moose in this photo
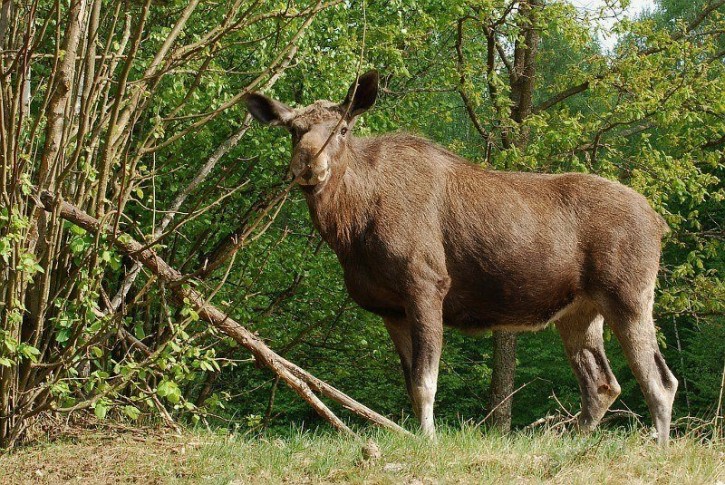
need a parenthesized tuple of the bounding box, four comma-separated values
(0, 0, 339, 447)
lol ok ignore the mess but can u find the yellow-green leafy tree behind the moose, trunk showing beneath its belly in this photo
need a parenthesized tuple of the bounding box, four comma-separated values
(382, 1, 723, 430)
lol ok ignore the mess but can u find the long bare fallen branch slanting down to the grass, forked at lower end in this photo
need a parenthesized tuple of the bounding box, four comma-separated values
(40, 191, 410, 435)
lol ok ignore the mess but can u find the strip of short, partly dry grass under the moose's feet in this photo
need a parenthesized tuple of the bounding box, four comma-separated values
(0, 427, 725, 485)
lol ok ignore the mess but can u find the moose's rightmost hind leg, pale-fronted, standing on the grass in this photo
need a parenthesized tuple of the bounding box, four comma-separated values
(610, 305, 678, 444)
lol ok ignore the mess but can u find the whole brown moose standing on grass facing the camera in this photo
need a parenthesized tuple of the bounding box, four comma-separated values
(245, 71, 678, 444)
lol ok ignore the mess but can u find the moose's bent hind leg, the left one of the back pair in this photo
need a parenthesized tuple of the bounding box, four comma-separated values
(556, 312, 621, 432)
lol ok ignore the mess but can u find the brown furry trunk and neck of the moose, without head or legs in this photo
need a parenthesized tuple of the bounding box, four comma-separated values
(306, 135, 663, 330)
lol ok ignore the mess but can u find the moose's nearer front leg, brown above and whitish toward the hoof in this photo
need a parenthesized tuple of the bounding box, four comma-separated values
(406, 295, 443, 437)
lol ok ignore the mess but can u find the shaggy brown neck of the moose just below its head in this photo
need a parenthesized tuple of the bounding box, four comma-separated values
(303, 137, 375, 256)
